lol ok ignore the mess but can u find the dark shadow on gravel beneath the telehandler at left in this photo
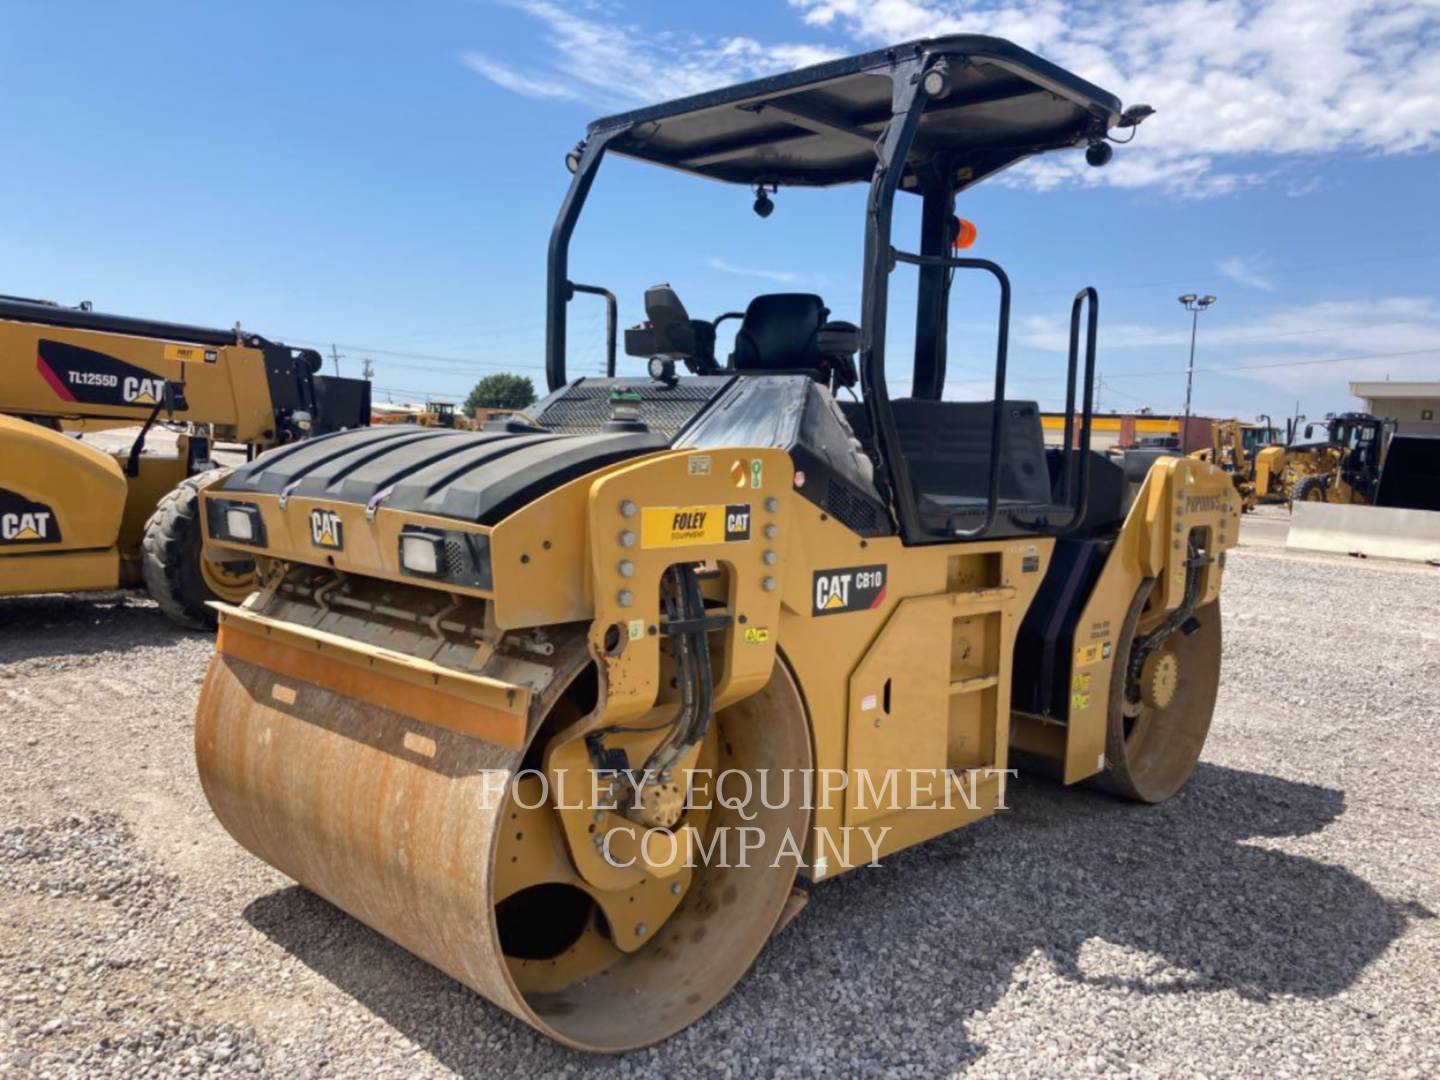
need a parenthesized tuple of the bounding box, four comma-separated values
(0, 592, 194, 664)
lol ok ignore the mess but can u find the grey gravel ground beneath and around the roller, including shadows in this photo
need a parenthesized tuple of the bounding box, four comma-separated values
(0, 547, 1440, 1077)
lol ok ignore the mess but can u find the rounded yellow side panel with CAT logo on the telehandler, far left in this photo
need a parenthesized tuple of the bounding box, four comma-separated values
(0, 416, 125, 559)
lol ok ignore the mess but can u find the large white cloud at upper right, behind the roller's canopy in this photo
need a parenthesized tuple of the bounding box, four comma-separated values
(791, 0, 1440, 196)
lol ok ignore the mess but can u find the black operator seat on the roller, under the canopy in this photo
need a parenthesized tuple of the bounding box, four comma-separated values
(730, 292, 860, 386)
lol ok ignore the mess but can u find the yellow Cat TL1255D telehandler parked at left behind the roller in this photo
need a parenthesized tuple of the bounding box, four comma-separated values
(0, 297, 370, 629)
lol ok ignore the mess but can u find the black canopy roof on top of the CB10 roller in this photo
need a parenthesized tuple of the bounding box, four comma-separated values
(590, 35, 1120, 189)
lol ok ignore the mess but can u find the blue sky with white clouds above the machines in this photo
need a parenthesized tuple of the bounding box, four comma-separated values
(0, 0, 1440, 416)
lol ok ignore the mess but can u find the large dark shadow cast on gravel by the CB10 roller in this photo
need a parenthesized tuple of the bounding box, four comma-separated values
(245, 765, 1431, 1074)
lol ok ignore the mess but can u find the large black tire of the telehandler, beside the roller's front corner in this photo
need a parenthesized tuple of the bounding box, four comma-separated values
(140, 468, 253, 629)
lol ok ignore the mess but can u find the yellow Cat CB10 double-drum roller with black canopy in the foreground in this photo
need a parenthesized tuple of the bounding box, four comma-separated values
(196, 36, 1238, 1051)
